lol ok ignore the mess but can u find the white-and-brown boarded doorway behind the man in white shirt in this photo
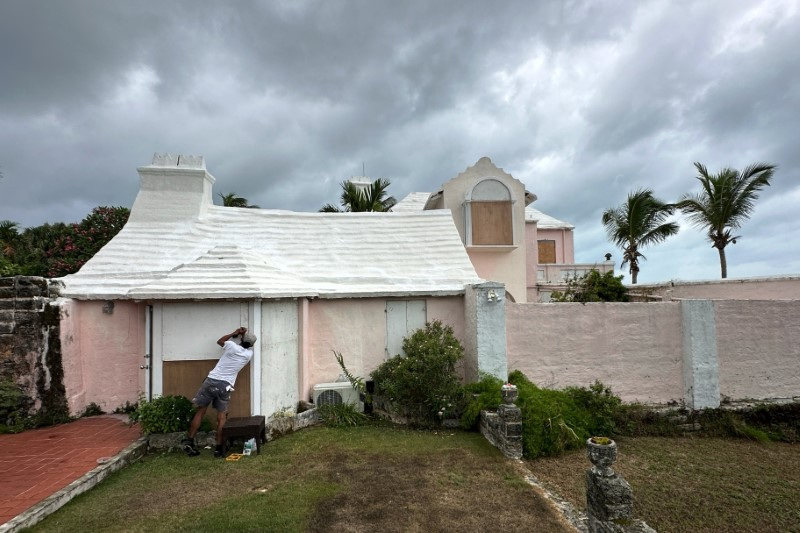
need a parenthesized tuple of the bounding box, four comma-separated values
(158, 302, 251, 422)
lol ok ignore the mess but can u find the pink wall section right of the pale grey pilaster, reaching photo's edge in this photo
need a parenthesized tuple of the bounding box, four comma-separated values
(714, 300, 800, 400)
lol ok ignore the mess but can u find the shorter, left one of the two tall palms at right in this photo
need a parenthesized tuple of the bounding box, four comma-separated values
(603, 189, 679, 284)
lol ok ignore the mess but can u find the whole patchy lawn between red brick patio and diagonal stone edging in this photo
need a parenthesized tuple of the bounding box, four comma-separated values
(28, 423, 580, 533)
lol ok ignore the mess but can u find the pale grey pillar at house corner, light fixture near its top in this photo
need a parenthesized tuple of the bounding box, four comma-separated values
(464, 281, 508, 382)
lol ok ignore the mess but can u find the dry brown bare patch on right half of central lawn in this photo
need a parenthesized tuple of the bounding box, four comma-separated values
(309, 450, 571, 533)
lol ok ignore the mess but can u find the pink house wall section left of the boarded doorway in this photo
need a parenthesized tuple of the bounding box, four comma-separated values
(61, 300, 145, 414)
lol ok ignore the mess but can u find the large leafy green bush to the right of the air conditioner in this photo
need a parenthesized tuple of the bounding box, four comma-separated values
(372, 320, 464, 425)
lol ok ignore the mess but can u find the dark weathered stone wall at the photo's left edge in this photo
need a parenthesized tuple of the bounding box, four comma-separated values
(0, 276, 67, 424)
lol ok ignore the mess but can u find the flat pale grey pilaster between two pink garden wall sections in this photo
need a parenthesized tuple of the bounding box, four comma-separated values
(681, 300, 719, 409)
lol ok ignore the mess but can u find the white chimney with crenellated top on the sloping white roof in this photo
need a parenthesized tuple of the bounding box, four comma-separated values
(129, 154, 215, 222)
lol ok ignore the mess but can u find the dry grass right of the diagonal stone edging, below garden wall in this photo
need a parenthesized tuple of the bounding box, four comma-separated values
(528, 437, 800, 533)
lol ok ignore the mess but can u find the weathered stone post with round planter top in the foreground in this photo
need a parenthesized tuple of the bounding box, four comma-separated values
(586, 437, 655, 533)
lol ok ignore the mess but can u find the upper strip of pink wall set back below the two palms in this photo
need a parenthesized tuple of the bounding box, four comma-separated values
(630, 276, 800, 300)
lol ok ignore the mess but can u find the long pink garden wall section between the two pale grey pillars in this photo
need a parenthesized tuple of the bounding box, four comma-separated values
(506, 302, 683, 403)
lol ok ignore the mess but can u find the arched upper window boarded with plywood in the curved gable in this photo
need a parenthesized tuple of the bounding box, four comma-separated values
(467, 179, 514, 246)
